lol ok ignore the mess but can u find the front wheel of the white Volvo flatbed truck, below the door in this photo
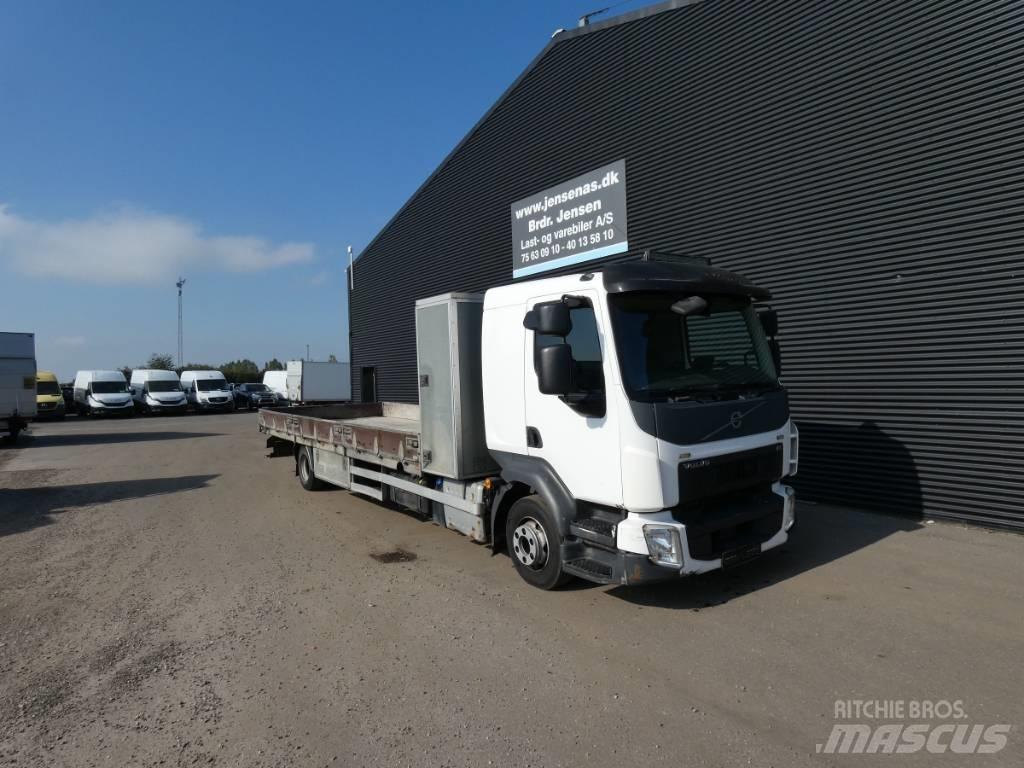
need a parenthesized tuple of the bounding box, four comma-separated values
(505, 496, 572, 590)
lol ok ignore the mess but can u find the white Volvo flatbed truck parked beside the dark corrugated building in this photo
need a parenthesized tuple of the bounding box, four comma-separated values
(259, 258, 799, 589)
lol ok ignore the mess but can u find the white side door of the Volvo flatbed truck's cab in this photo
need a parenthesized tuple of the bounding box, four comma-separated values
(523, 291, 623, 506)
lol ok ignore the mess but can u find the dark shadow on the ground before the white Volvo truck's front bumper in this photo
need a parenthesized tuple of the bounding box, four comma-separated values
(608, 505, 922, 610)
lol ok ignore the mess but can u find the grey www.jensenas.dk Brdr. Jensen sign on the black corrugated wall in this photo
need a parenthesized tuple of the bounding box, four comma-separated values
(512, 160, 630, 278)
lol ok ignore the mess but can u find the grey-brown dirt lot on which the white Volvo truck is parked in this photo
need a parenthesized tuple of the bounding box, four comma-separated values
(0, 414, 1024, 768)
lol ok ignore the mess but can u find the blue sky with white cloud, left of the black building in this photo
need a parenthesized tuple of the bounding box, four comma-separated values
(0, 0, 645, 379)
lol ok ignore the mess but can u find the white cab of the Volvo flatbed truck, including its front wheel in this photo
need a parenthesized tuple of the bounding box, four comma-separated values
(481, 260, 799, 587)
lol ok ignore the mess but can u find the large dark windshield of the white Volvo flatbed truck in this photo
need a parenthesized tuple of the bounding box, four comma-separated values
(609, 293, 778, 402)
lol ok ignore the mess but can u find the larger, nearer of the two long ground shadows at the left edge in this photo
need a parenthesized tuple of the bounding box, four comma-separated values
(0, 475, 219, 538)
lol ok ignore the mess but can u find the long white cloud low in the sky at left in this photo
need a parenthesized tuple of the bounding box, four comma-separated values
(0, 205, 313, 283)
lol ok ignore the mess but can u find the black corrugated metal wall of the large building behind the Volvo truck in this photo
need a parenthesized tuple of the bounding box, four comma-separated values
(351, 0, 1024, 526)
